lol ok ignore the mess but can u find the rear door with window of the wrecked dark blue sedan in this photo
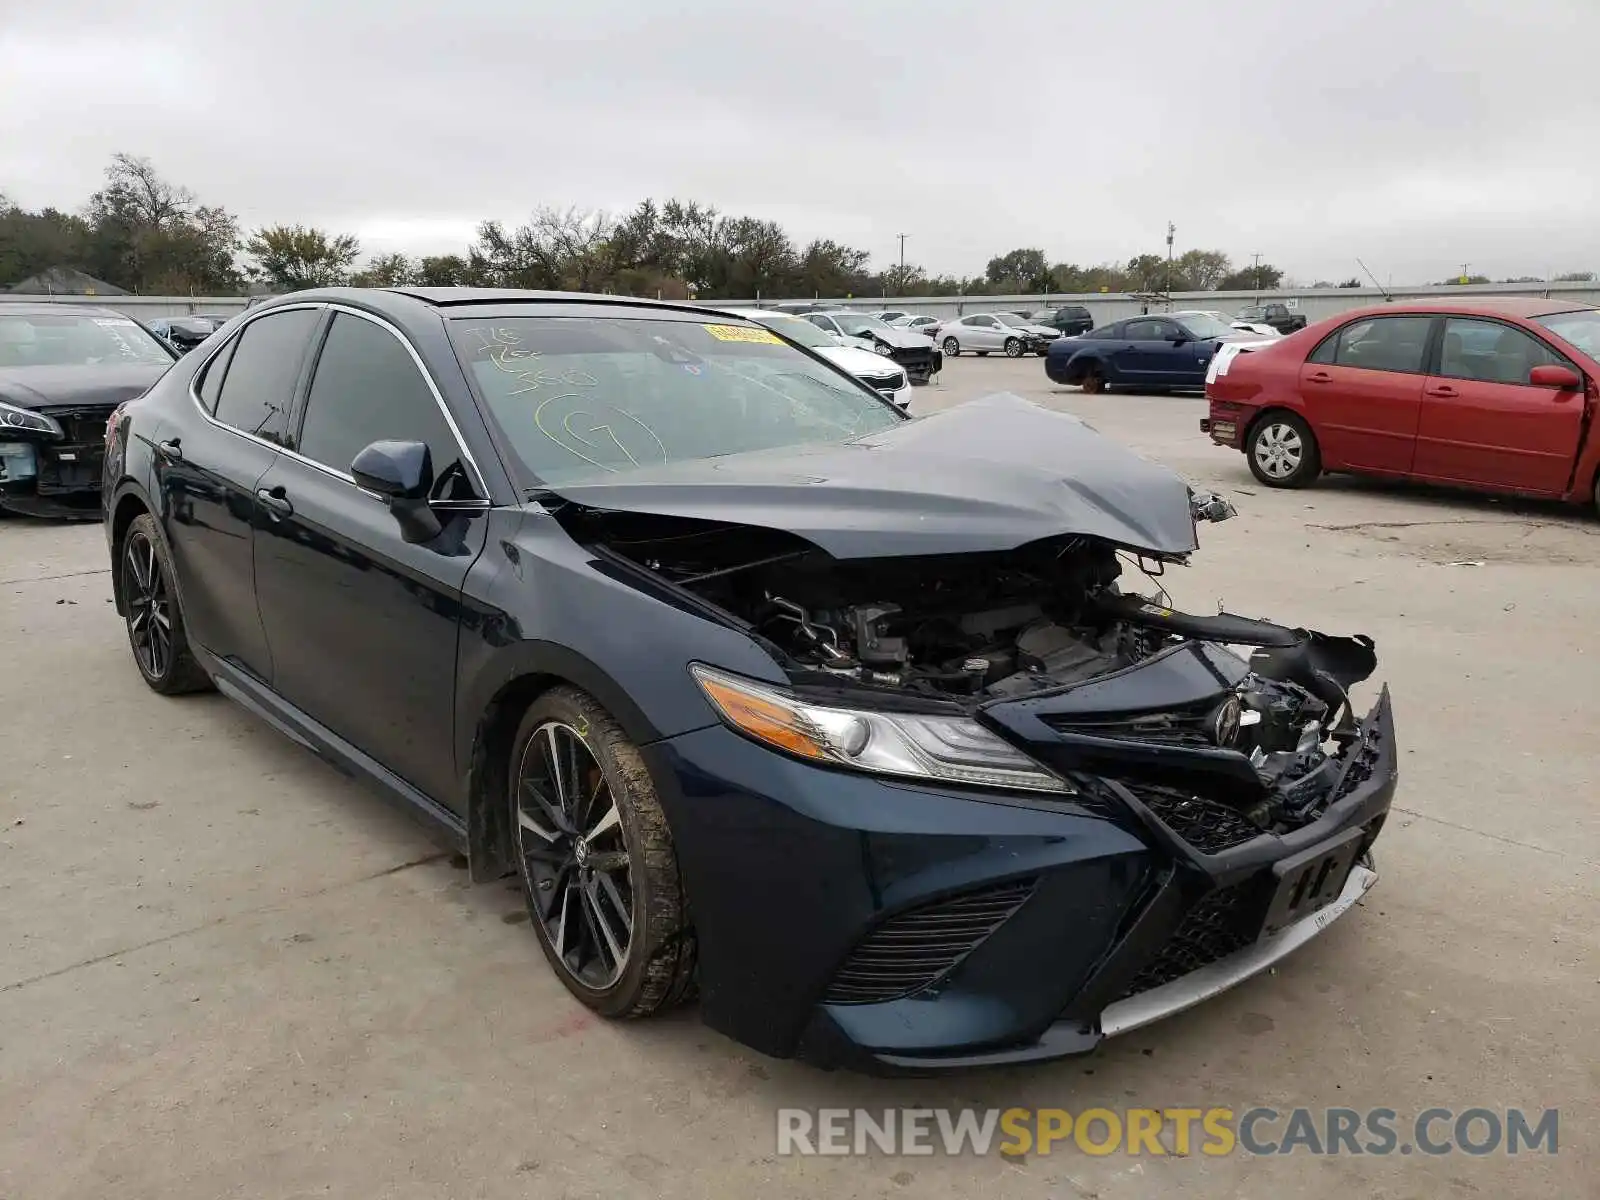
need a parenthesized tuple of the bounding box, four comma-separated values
(155, 307, 322, 680)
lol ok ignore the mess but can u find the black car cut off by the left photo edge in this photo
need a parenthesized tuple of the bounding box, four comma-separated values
(0, 302, 174, 518)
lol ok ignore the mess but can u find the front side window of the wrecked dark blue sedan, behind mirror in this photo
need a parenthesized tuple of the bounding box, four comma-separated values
(294, 312, 466, 498)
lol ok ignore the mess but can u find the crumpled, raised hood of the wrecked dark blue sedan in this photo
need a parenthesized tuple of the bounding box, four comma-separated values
(549, 394, 1197, 558)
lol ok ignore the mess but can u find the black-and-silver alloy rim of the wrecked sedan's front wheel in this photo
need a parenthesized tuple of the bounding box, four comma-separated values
(515, 720, 634, 992)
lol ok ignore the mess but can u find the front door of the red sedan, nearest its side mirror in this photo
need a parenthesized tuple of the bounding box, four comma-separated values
(1413, 317, 1584, 494)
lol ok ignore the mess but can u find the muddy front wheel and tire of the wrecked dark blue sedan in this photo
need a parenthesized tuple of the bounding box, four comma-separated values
(509, 688, 694, 1019)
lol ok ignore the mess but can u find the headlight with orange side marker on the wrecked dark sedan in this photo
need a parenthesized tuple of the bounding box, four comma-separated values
(690, 662, 1074, 795)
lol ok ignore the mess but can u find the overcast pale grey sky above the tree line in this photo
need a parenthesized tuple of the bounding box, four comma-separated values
(0, 0, 1600, 283)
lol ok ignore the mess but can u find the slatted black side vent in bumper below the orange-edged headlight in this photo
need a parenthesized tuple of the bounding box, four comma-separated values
(822, 878, 1037, 1005)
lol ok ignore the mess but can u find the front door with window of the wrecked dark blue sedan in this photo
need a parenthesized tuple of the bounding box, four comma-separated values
(246, 310, 486, 805)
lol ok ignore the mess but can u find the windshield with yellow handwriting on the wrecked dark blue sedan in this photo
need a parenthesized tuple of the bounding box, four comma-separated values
(450, 317, 904, 485)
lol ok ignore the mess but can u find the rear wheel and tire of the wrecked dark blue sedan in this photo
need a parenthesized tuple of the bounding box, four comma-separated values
(117, 512, 211, 696)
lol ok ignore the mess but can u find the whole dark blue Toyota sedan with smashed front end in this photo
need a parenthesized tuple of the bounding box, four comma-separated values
(104, 288, 1395, 1070)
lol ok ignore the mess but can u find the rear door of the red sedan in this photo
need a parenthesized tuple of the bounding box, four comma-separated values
(1299, 315, 1435, 475)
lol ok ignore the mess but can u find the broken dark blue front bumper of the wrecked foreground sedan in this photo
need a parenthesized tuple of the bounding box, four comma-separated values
(643, 693, 1397, 1072)
